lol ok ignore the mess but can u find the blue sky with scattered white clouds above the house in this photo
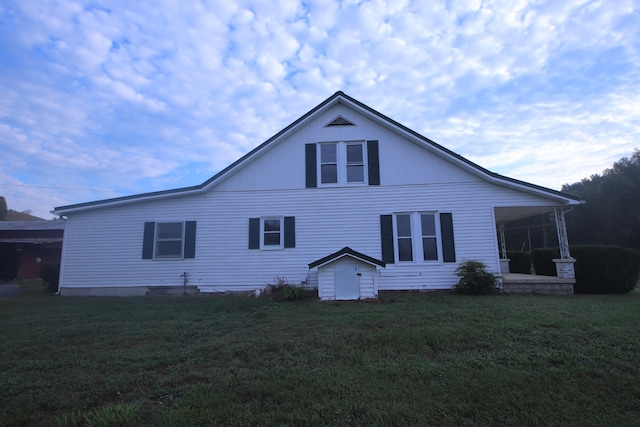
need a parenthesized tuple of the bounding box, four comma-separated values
(0, 0, 640, 219)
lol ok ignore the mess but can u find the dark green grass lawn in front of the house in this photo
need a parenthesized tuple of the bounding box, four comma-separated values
(0, 285, 640, 426)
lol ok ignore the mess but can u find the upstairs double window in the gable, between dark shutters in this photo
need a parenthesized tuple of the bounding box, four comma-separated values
(318, 142, 366, 185)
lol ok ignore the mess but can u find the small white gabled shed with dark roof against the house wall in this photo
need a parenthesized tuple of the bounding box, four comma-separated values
(309, 247, 385, 300)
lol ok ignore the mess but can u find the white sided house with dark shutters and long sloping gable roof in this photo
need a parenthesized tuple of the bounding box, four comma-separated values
(54, 92, 580, 299)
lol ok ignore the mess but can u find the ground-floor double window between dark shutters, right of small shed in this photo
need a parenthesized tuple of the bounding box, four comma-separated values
(394, 212, 440, 262)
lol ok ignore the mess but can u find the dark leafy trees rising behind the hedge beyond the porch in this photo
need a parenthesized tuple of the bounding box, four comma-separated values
(562, 149, 640, 249)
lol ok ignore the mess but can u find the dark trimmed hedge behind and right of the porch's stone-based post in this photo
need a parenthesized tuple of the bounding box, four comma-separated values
(532, 245, 640, 294)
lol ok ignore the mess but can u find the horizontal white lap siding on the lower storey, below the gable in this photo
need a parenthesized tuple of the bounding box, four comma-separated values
(62, 182, 560, 291)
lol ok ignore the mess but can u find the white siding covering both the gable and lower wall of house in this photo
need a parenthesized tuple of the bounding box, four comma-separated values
(61, 101, 568, 297)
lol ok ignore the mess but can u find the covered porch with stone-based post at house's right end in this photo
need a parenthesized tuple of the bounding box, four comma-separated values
(495, 206, 576, 295)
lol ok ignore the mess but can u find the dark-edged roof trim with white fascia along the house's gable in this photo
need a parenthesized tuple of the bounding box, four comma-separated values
(53, 91, 581, 215)
